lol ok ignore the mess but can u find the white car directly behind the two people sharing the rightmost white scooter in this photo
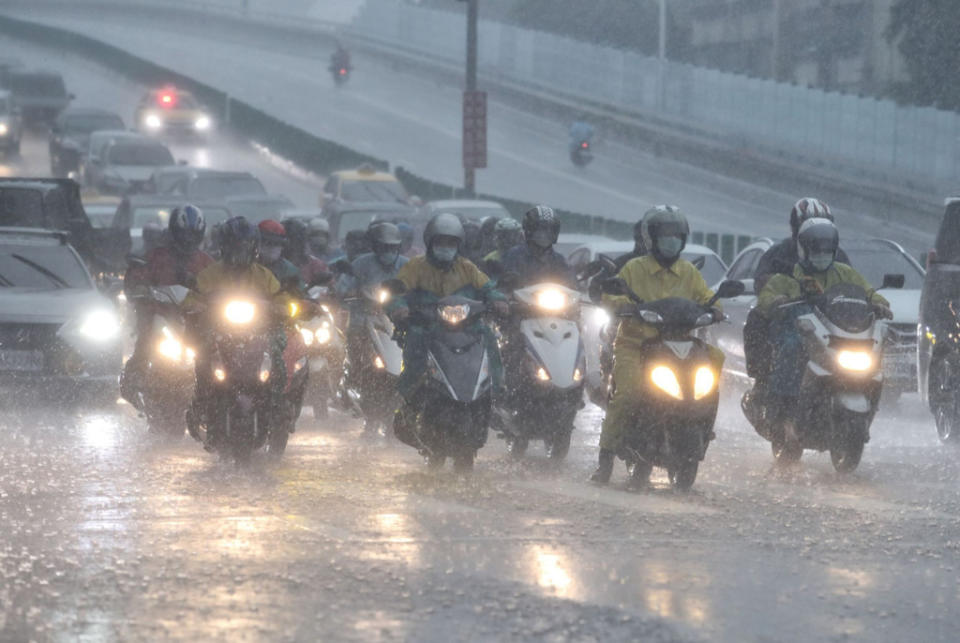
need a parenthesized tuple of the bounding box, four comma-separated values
(711, 238, 925, 400)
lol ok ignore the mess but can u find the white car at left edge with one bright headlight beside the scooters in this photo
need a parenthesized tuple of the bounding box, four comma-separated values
(0, 227, 123, 403)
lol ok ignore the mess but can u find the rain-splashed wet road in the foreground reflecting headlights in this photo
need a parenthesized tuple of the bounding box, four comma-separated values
(0, 390, 960, 641)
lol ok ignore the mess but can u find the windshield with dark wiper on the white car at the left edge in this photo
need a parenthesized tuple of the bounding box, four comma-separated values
(0, 240, 91, 290)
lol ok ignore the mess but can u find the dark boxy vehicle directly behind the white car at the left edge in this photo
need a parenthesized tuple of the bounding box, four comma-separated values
(0, 177, 130, 276)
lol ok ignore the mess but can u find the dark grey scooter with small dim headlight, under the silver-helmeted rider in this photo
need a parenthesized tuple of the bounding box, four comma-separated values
(385, 280, 493, 472)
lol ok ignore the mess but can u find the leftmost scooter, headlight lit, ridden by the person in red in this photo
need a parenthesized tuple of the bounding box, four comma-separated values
(132, 286, 196, 436)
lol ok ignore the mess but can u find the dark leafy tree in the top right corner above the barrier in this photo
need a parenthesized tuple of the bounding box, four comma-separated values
(885, 0, 960, 110)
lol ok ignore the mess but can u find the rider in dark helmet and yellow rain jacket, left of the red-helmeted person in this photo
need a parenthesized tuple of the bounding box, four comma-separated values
(183, 216, 289, 450)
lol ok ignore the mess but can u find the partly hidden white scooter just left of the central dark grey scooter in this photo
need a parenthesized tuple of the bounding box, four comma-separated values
(344, 286, 403, 430)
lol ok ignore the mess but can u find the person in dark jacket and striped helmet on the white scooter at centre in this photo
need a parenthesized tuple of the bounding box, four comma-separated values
(503, 205, 576, 288)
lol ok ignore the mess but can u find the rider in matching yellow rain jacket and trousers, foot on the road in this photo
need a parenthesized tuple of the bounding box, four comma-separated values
(590, 205, 723, 484)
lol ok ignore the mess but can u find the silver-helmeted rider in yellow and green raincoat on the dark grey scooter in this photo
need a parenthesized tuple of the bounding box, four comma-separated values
(387, 213, 509, 443)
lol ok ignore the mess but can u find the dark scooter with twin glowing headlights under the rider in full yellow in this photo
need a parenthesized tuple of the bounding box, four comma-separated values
(602, 278, 744, 491)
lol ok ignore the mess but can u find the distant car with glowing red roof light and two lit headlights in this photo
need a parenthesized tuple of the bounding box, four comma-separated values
(133, 86, 214, 137)
